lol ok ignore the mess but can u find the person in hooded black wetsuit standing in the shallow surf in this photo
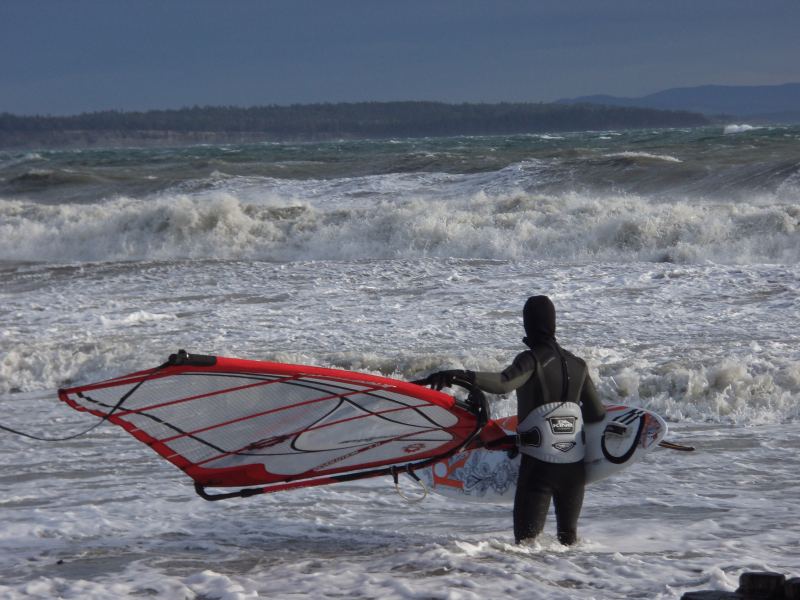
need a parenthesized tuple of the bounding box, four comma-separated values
(430, 296, 605, 545)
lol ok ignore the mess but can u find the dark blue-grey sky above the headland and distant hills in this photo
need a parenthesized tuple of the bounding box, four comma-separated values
(0, 0, 800, 115)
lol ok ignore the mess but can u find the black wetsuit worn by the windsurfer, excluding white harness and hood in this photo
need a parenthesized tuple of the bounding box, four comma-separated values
(475, 342, 605, 544)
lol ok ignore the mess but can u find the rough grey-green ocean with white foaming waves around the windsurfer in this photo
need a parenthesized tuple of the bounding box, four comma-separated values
(0, 125, 800, 600)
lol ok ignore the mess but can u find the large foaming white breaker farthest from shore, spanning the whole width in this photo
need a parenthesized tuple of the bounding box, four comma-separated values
(0, 178, 800, 263)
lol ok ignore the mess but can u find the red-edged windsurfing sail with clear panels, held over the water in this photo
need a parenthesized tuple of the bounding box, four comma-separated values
(59, 351, 486, 499)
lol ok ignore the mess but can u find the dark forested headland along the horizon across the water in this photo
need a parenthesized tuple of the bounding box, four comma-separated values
(0, 102, 709, 148)
